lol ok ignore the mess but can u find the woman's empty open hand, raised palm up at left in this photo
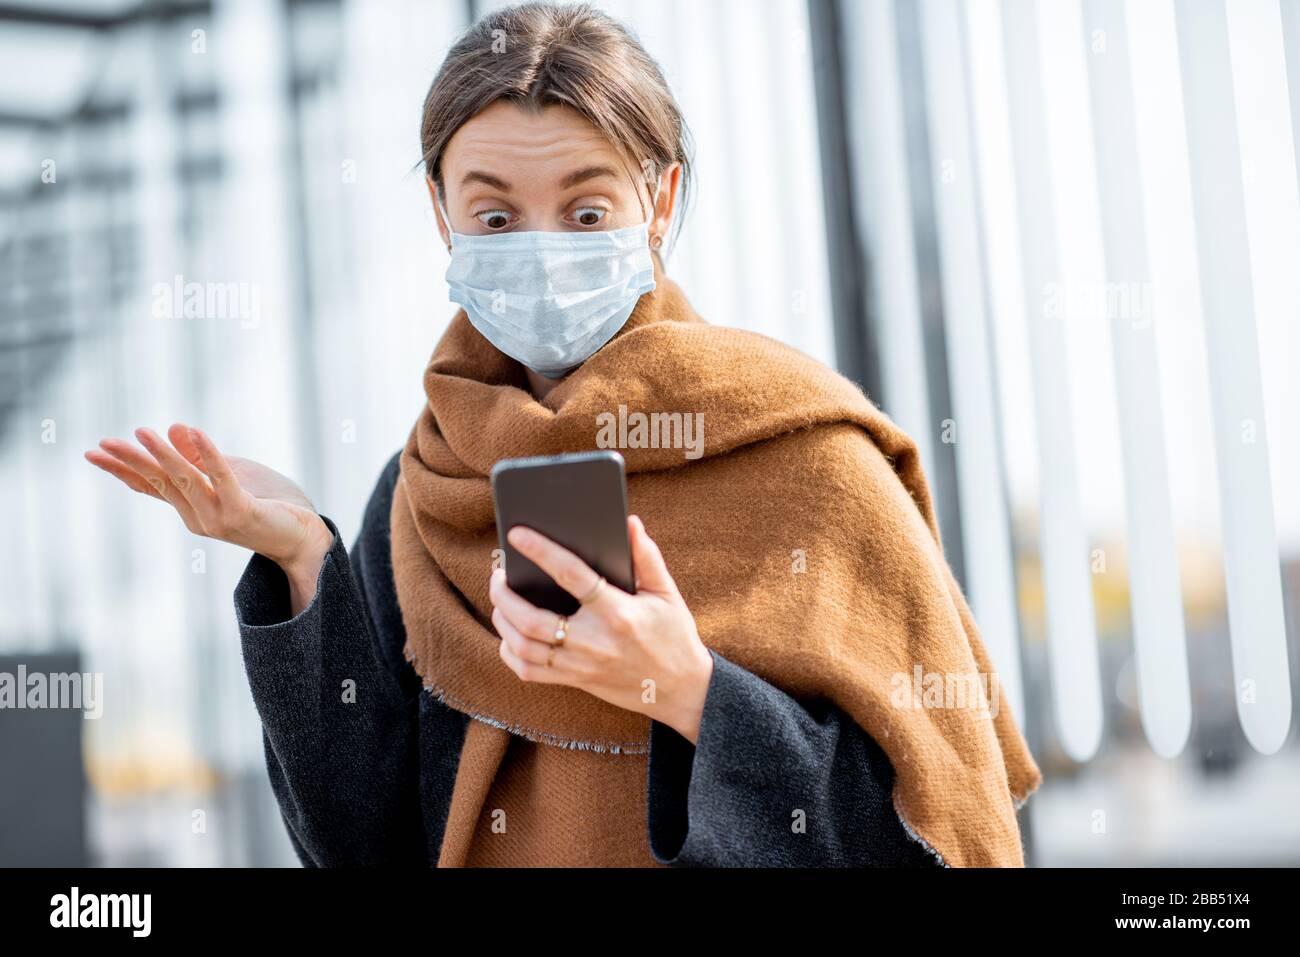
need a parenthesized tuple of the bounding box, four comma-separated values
(86, 423, 334, 615)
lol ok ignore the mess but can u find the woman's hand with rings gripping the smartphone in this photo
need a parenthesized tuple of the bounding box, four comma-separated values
(489, 515, 714, 744)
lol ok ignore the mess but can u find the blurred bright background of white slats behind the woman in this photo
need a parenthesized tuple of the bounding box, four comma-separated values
(0, 0, 1300, 866)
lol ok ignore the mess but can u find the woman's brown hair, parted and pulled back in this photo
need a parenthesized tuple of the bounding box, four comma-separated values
(420, 0, 692, 257)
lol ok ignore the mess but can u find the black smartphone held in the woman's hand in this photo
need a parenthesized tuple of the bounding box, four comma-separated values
(491, 450, 637, 615)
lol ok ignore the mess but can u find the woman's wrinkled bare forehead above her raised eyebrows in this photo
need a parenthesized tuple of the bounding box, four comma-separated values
(442, 100, 628, 190)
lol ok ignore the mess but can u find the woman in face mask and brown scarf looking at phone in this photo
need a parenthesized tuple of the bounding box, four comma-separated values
(87, 3, 1040, 866)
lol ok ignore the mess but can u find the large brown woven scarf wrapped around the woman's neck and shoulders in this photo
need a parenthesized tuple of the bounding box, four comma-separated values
(391, 254, 1041, 866)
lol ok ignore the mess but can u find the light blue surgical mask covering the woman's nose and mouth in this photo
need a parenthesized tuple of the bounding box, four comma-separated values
(439, 202, 655, 378)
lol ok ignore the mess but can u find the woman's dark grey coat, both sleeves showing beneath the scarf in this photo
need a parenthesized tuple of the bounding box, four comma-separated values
(234, 455, 940, 867)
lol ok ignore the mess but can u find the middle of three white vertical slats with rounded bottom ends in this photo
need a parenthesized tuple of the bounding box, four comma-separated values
(1084, 0, 1192, 757)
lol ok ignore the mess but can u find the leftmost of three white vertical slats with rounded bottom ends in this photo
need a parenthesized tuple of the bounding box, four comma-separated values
(1002, 1, 1102, 761)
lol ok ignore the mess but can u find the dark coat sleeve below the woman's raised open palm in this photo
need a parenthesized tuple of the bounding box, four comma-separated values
(234, 452, 428, 867)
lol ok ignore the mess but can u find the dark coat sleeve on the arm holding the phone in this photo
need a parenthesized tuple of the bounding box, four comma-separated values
(647, 650, 941, 867)
